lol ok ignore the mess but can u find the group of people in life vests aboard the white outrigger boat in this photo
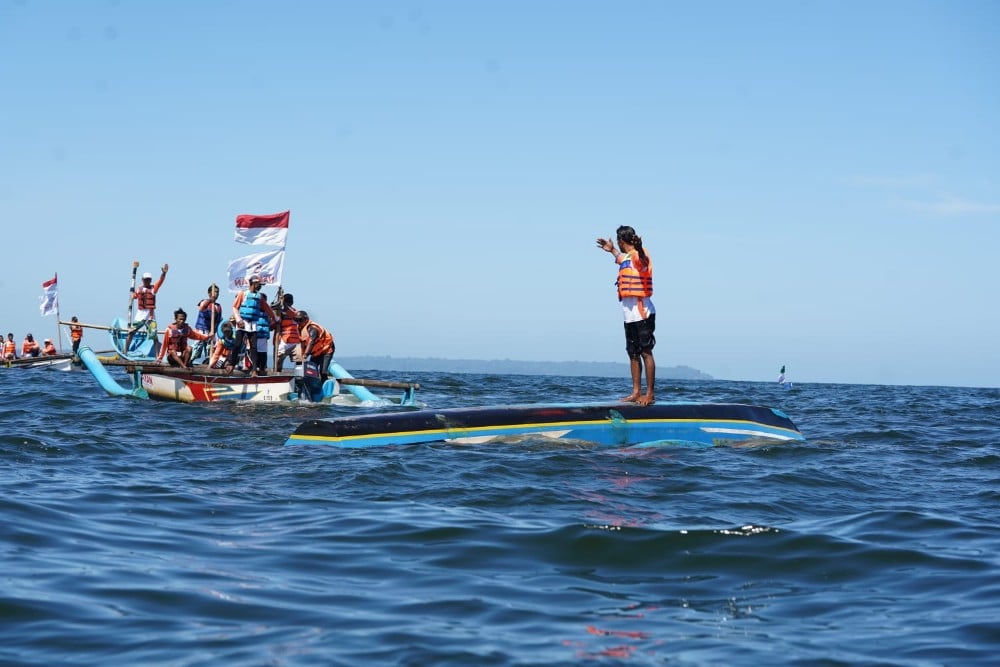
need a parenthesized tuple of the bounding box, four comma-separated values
(124, 264, 336, 377)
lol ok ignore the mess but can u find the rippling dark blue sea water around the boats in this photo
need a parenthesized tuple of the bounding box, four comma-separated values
(0, 369, 1000, 666)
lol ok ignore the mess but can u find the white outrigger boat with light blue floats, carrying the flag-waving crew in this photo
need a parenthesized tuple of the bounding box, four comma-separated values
(79, 347, 420, 407)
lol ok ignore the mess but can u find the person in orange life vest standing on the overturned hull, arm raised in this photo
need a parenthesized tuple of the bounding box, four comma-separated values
(597, 225, 656, 405)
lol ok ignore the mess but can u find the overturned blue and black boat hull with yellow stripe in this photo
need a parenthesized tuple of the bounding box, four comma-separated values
(285, 402, 804, 448)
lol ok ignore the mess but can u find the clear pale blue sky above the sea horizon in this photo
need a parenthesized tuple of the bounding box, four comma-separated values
(0, 0, 1000, 387)
